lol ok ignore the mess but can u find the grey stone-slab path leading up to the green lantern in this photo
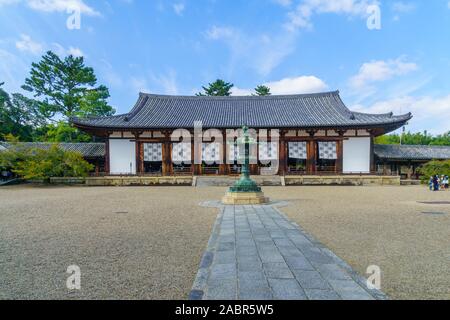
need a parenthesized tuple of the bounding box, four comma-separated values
(189, 206, 386, 300)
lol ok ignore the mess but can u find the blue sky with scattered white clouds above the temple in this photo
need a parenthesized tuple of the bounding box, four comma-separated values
(0, 0, 450, 133)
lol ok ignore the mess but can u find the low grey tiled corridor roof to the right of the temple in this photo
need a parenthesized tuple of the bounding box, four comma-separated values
(374, 145, 450, 160)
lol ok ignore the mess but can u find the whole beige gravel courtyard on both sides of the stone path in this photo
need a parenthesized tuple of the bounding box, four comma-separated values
(0, 186, 450, 299)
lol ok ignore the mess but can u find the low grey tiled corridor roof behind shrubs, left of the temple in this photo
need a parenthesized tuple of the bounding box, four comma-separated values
(0, 142, 105, 158)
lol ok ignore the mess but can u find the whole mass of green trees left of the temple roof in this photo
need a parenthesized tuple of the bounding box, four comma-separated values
(0, 51, 115, 142)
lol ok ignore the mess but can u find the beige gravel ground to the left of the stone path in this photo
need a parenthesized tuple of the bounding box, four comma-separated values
(0, 187, 218, 299)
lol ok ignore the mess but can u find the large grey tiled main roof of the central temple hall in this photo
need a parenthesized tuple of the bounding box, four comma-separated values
(72, 91, 412, 129)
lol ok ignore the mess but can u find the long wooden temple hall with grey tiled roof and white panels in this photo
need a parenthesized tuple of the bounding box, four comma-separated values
(72, 92, 412, 176)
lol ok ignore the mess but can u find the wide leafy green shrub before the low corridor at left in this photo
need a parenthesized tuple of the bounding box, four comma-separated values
(0, 144, 94, 181)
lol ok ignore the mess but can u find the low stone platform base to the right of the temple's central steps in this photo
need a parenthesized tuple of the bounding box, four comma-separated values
(284, 175, 400, 186)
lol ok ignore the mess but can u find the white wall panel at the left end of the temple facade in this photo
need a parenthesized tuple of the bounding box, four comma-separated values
(109, 139, 136, 174)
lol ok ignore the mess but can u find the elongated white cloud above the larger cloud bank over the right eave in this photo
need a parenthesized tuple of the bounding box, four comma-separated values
(350, 57, 418, 89)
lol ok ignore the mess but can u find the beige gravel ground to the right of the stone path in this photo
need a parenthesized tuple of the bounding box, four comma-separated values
(273, 186, 450, 299)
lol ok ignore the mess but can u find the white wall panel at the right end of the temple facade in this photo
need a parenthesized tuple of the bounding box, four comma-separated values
(343, 137, 370, 173)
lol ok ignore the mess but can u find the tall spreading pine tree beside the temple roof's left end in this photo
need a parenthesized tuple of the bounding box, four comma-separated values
(23, 51, 115, 120)
